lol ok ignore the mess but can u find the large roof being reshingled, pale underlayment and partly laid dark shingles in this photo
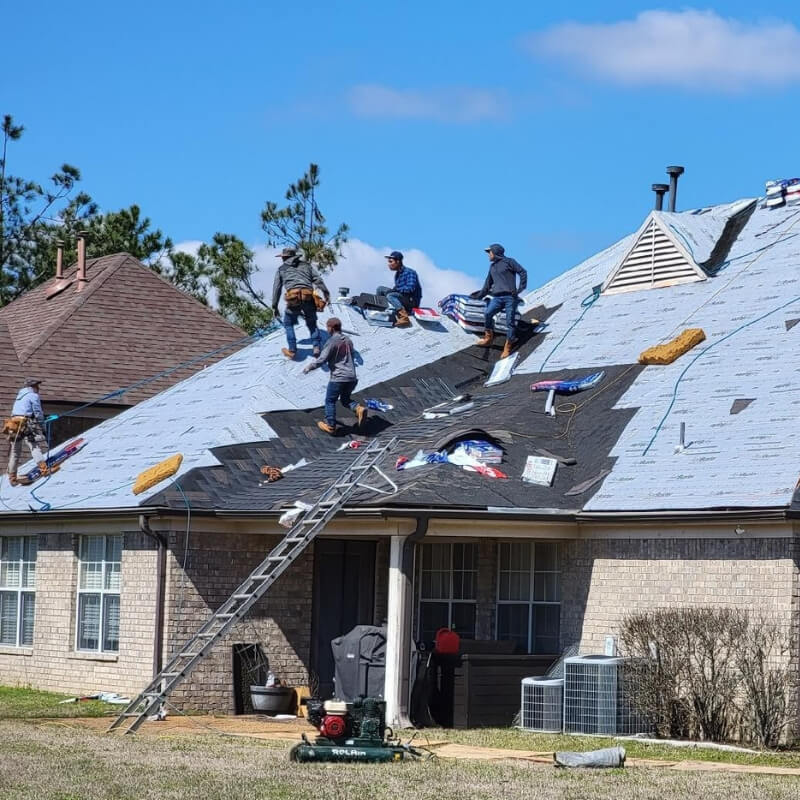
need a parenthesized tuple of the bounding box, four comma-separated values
(0, 196, 800, 513)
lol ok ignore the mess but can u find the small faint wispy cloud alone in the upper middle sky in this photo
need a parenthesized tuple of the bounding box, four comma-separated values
(347, 84, 511, 123)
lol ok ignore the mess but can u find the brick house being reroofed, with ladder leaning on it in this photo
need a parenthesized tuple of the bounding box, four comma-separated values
(0, 192, 800, 723)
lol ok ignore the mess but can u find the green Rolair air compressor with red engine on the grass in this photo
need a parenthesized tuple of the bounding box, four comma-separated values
(289, 697, 423, 763)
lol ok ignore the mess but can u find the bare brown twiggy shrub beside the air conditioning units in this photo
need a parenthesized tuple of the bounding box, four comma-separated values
(620, 607, 794, 747)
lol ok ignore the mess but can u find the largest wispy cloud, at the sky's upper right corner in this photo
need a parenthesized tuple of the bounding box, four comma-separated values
(525, 9, 800, 92)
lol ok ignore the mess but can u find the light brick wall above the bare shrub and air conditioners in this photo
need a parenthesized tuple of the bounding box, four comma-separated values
(561, 536, 798, 653)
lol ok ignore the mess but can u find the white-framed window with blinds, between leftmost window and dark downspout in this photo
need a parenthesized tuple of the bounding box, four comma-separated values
(75, 536, 122, 653)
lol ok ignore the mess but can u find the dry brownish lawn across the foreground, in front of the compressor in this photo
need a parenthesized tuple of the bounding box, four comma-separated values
(0, 719, 800, 800)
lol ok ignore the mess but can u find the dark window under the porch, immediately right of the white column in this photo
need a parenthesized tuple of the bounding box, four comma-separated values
(419, 544, 478, 641)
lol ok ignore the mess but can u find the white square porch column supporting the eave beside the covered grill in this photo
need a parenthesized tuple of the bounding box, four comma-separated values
(384, 535, 411, 728)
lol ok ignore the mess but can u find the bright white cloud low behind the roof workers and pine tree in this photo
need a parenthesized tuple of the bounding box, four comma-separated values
(253, 239, 480, 306)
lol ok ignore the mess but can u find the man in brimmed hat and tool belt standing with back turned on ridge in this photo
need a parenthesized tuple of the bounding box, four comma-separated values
(272, 247, 331, 358)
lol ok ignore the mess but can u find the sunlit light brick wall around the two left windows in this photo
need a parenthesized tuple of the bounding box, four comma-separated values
(0, 531, 156, 694)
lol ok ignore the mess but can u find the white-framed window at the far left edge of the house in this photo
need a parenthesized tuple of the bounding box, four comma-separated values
(0, 536, 39, 647)
